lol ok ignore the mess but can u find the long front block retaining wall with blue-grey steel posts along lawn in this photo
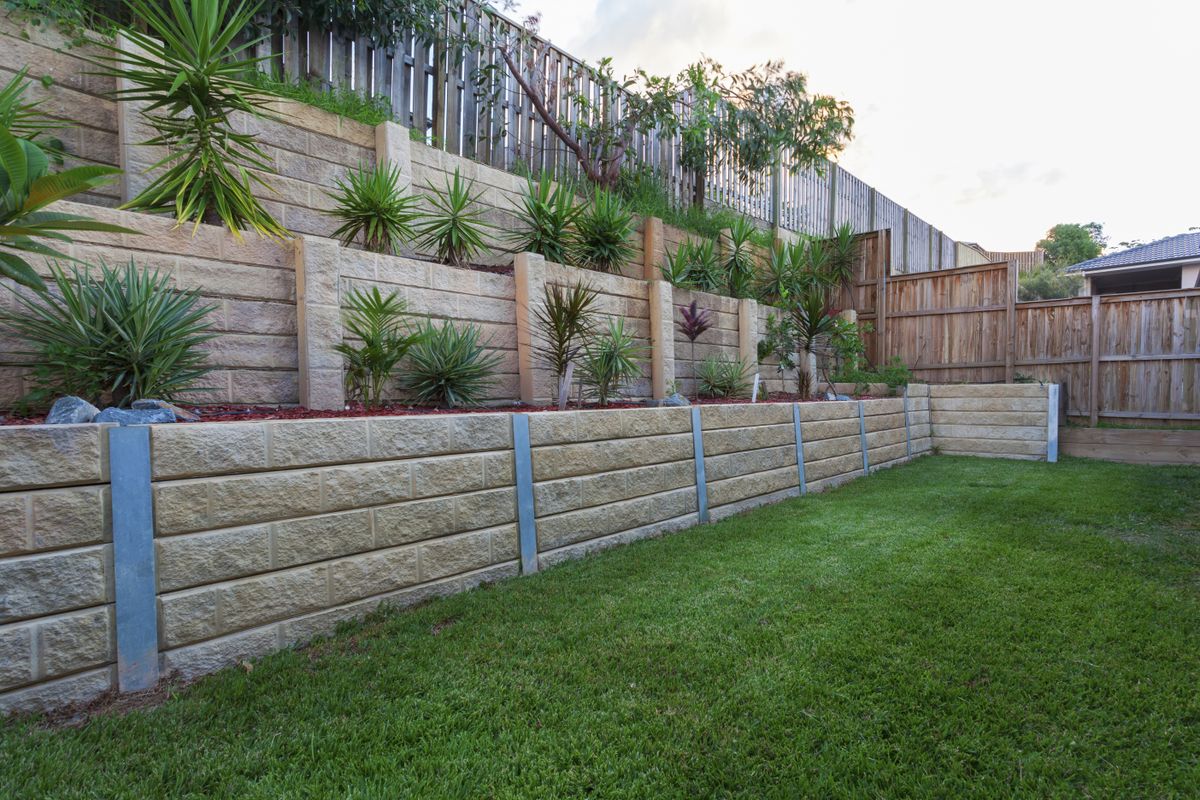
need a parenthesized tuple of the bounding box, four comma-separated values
(0, 386, 1056, 712)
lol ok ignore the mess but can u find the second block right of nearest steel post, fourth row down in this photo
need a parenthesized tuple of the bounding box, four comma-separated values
(220, 564, 330, 632)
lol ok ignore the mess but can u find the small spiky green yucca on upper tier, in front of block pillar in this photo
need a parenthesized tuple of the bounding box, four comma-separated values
(329, 164, 421, 255)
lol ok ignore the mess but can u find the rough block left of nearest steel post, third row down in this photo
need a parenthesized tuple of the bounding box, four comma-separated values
(0, 545, 112, 624)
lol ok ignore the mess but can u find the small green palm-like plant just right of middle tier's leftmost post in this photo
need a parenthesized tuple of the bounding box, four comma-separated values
(334, 287, 421, 407)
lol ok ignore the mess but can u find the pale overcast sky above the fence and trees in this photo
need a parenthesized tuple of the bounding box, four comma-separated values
(518, 0, 1200, 249)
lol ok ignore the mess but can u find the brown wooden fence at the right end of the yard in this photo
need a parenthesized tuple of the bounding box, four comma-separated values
(856, 261, 1200, 425)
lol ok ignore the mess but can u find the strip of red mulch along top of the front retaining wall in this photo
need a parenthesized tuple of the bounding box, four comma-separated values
(0, 392, 871, 426)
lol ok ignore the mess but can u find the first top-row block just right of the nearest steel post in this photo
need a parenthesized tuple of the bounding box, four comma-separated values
(150, 422, 269, 481)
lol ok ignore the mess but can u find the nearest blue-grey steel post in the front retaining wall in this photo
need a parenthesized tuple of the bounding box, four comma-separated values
(108, 426, 158, 692)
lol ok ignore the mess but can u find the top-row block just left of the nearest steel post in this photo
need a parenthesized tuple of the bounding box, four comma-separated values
(0, 425, 108, 492)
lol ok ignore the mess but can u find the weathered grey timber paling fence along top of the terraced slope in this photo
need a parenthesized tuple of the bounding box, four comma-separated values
(253, 0, 955, 272)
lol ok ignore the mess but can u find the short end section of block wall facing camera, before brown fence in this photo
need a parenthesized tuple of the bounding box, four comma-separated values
(929, 384, 1057, 459)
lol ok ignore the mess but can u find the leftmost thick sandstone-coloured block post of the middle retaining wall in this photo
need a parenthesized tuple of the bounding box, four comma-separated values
(295, 236, 346, 409)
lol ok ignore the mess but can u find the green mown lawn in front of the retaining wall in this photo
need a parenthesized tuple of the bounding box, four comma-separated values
(0, 457, 1200, 798)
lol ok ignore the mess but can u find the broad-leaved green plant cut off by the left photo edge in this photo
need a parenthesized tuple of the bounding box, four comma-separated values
(0, 127, 137, 291)
